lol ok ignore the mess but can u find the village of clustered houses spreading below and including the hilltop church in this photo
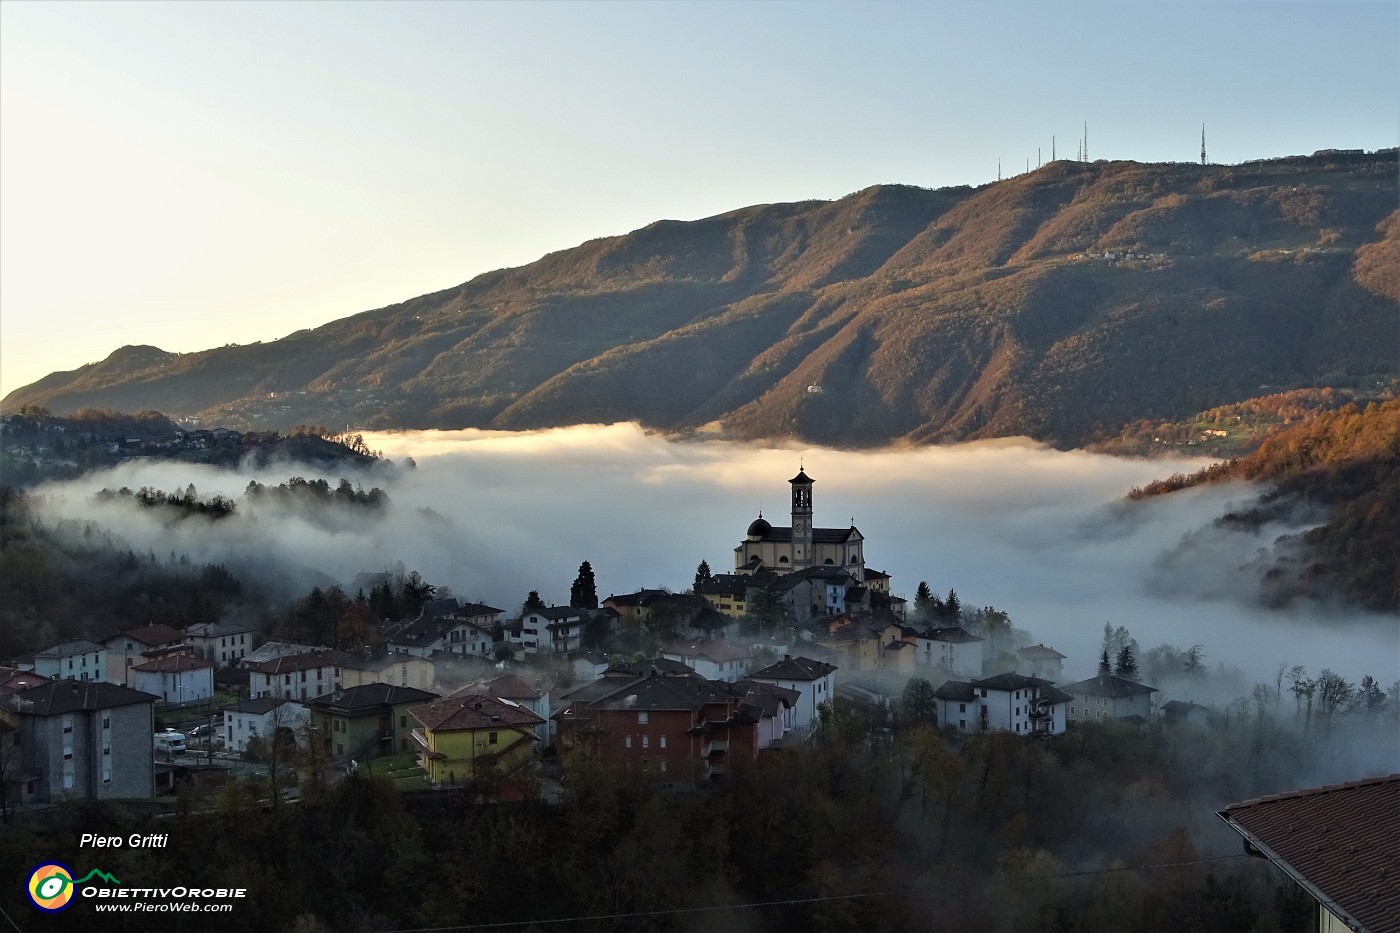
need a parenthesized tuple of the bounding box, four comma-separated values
(0, 469, 1207, 810)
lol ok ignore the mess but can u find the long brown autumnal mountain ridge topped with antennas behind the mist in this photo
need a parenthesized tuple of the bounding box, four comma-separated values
(0, 150, 1400, 445)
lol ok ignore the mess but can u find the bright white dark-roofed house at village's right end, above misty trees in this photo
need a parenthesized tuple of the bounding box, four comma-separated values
(934, 674, 1071, 737)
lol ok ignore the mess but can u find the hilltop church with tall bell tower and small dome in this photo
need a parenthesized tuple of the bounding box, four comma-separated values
(734, 468, 865, 583)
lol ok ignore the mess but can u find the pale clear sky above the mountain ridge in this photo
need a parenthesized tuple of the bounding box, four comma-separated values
(0, 0, 1400, 392)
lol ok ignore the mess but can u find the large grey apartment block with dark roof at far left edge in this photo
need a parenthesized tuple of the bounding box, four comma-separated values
(0, 681, 155, 804)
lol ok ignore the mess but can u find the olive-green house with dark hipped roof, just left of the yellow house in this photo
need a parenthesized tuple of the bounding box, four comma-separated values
(305, 684, 438, 761)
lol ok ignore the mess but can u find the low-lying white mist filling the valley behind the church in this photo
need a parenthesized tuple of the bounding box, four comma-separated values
(36, 424, 1400, 689)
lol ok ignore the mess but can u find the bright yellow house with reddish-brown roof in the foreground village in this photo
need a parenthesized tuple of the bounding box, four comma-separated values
(412, 692, 545, 785)
